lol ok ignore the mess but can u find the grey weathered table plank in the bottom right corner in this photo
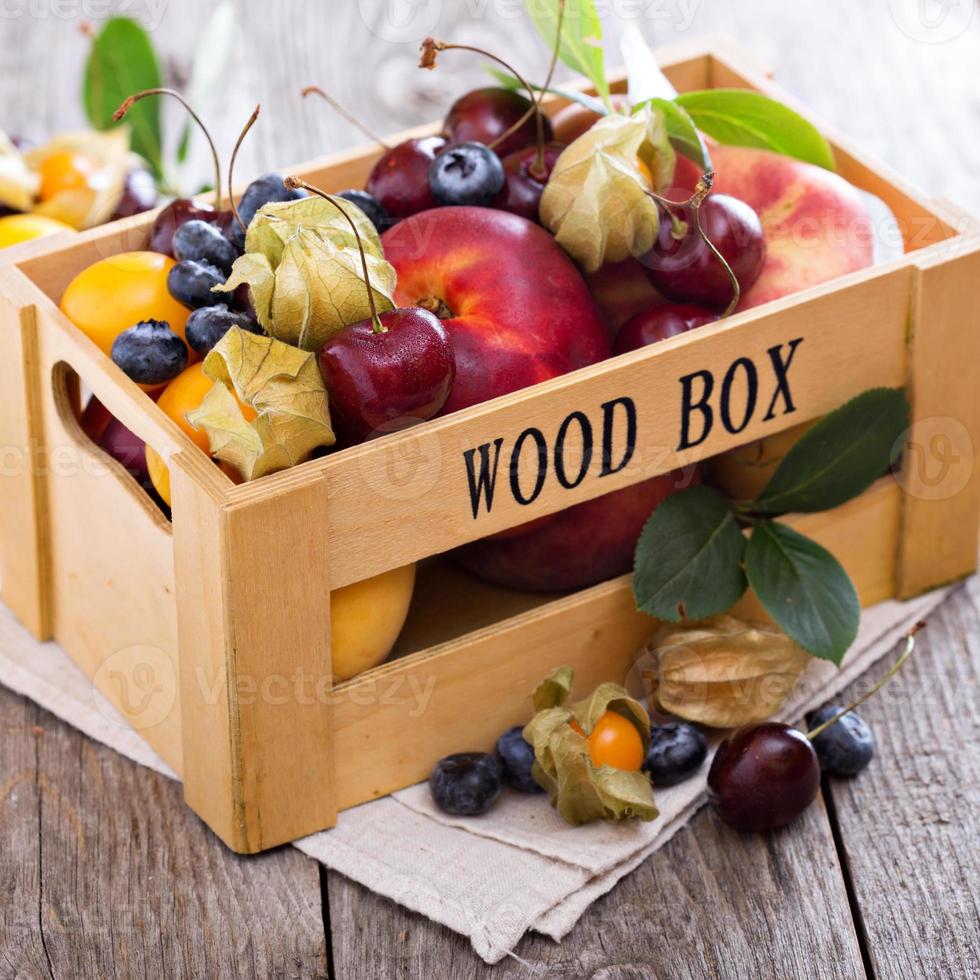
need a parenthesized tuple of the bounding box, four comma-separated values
(825, 577, 980, 980)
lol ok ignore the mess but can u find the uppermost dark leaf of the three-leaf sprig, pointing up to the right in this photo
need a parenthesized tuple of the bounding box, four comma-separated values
(751, 388, 909, 514)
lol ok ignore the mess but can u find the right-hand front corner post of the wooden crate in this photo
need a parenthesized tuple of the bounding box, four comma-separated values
(895, 215, 980, 599)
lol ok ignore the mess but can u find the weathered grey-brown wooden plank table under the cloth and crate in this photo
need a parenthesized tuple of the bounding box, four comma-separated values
(0, 0, 980, 980)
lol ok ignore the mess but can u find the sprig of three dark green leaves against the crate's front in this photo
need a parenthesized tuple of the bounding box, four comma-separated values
(633, 388, 909, 665)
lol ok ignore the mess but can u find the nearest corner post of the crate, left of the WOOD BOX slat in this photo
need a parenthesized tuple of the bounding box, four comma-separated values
(170, 452, 337, 853)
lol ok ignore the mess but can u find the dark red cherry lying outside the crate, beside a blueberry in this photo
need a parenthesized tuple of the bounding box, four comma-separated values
(708, 722, 820, 832)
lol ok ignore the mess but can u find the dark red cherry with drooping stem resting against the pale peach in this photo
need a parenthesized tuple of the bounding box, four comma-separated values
(641, 194, 766, 310)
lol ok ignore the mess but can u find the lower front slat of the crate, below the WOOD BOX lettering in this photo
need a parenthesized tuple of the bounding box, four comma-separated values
(334, 478, 900, 809)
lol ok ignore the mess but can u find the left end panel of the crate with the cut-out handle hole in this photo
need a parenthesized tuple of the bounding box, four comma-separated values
(38, 304, 182, 772)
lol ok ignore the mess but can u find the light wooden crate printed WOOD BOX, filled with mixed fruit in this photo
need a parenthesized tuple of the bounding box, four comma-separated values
(0, 41, 980, 852)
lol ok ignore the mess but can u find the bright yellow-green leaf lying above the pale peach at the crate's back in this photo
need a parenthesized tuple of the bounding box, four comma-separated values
(675, 88, 834, 170)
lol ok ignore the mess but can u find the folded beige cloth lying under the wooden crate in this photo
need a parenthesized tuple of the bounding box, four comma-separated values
(0, 589, 950, 963)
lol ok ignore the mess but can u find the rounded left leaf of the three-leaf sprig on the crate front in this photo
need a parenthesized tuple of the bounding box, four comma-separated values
(633, 486, 746, 622)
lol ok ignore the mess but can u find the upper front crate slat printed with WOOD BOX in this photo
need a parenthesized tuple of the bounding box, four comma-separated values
(312, 268, 911, 586)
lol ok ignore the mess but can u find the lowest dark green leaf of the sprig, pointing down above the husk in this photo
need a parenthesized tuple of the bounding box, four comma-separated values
(745, 521, 861, 666)
